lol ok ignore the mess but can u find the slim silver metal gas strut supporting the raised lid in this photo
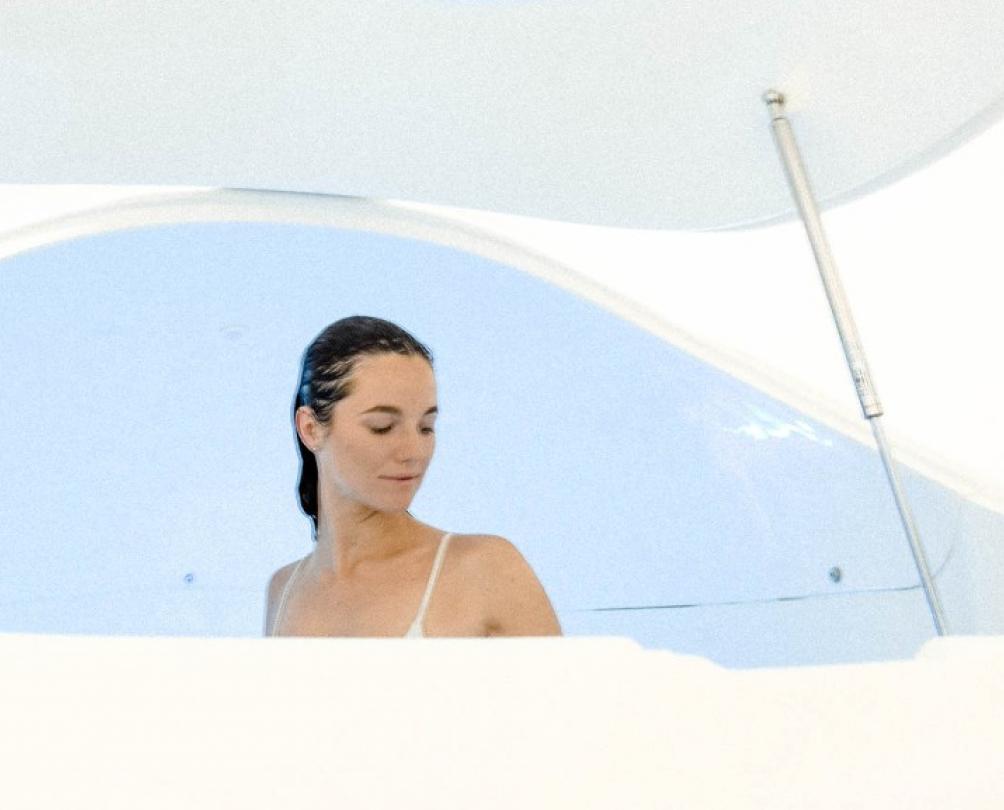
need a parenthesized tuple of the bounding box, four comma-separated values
(763, 90, 948, 635)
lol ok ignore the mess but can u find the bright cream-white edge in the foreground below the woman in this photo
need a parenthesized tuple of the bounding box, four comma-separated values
(0, 634, 1004, 810)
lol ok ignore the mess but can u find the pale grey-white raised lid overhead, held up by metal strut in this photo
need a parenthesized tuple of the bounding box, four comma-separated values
(0, 0, 1004, 228)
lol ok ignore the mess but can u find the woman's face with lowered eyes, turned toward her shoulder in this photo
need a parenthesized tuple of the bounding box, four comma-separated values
(314, 352, 437, 512)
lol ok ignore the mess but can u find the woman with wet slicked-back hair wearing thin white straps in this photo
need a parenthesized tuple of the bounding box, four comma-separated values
(265, 316, 561, 637)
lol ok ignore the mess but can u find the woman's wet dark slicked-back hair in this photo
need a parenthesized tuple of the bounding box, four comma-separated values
(293, 315, 433, 540)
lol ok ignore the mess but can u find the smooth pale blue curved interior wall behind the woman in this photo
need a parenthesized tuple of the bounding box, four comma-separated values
(0, 224, 965, 665)
